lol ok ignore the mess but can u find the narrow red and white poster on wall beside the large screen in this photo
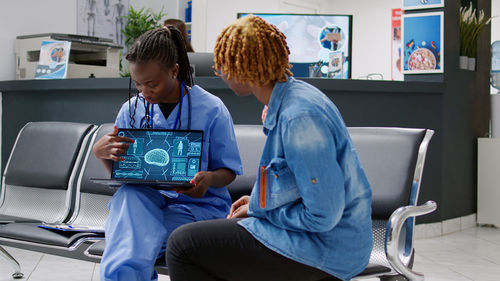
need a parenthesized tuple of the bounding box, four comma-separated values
(391, 9, 404, 81)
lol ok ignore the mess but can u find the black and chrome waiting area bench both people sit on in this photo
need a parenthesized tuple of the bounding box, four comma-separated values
(0, 122, 436, 280)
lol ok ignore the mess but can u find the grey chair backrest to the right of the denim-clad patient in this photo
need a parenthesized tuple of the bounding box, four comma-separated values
(348, 127, 426, 219)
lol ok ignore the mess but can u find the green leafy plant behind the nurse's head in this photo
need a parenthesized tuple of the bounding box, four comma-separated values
(120, 6, 167, 77)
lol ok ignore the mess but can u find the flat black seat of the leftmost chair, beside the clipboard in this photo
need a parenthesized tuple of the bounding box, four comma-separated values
(0, 223, 102, 247)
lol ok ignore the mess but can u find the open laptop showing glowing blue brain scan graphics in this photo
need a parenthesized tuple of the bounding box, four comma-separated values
(90, 129, 203, 189)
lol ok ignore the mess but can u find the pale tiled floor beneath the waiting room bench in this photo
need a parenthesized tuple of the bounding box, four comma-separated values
(0, 224, 500, 281)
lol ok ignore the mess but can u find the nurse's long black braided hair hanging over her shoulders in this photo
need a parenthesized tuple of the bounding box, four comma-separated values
(125, 26, 193, 128)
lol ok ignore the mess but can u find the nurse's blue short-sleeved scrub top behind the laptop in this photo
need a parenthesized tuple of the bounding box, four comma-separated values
(115, 86, 242, 219)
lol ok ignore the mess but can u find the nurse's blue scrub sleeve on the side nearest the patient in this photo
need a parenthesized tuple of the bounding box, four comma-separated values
(208, 106, 243, 175)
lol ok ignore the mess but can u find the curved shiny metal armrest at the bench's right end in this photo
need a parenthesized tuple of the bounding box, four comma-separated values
(385, 201, 437, 281)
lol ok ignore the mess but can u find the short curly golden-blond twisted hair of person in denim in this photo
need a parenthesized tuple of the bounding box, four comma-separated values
(214, 15, 293, 86)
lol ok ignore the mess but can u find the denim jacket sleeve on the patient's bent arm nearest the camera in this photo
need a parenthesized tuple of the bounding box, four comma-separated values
(266, 116, 345, 232)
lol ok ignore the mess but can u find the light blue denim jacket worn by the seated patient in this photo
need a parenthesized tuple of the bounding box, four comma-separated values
(239, 77, 373, 280)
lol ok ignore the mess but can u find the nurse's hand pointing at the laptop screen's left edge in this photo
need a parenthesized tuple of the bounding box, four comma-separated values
(92, 126, 134, 161)
